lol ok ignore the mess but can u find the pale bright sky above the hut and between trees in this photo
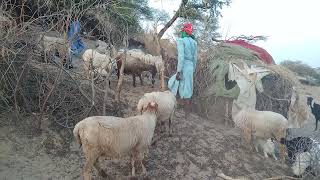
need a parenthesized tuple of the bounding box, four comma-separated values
(150, 0, 320, 67)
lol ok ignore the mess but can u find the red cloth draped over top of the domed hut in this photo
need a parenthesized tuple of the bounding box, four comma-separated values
(225, 40, 275, 64)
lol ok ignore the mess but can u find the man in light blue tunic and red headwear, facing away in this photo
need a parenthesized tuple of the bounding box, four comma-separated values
(168, 23, 198, 113)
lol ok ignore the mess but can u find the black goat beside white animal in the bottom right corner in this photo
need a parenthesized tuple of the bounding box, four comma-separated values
(280, 137, 313, 164)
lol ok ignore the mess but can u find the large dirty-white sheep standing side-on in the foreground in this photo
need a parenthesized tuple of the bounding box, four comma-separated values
(73, 102, 158, 180)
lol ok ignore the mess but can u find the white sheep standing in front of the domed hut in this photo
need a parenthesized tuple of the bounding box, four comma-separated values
(233, 108, 288, 161)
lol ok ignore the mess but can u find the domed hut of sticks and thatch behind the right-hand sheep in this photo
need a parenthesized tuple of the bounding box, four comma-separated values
(193, 43, 297, 121)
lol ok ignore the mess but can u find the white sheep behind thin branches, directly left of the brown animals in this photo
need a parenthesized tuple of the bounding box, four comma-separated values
(82, 49, 116, 79)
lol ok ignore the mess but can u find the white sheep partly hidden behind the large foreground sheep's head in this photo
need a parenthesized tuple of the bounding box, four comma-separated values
(137, 91, 177, 135)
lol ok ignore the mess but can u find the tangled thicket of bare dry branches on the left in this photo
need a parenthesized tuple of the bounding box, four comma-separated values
(0, 0, 135, 129)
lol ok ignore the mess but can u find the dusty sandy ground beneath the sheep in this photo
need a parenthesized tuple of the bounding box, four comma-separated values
(0, 44, 319, 180)
